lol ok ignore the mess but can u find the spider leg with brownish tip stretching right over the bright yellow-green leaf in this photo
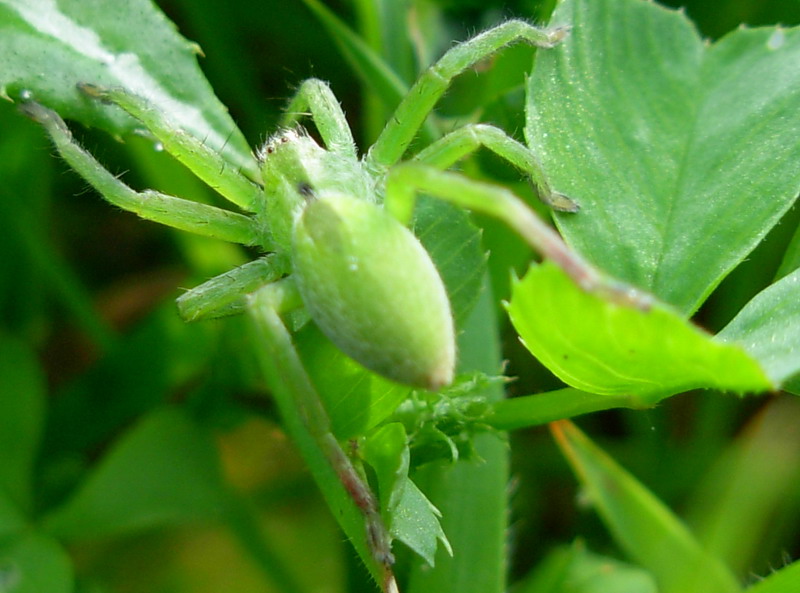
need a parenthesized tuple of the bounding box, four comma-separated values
(384, 162, 651, 310)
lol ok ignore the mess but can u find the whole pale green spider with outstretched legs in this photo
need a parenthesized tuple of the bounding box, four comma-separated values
(23, 20, 635, 591)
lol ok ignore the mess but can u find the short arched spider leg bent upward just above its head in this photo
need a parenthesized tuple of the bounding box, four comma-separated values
(280, 78, 356, 159)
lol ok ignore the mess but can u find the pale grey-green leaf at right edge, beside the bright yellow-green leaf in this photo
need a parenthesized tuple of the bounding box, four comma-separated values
(718, 269, 800, 384)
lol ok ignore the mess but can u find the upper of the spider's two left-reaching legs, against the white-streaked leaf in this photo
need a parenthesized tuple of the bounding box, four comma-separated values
(78, 84, 263, 212)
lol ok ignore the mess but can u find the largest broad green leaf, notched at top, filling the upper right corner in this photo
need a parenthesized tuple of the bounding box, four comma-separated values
(526, 0, 800, 314)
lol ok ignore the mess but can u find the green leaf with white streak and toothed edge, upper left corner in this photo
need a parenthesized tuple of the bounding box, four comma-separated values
(0, 0, 258, 178)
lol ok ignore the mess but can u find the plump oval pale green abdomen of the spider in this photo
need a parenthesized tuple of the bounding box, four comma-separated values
(292, 195, 455, 390)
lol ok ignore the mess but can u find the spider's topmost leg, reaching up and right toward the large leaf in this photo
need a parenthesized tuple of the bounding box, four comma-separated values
(367, 20, 569, 170)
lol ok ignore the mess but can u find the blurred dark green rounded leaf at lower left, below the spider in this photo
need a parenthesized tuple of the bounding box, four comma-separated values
(43, 408, 228, 540)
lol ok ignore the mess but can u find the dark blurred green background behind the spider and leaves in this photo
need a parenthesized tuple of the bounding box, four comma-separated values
(0, 0, 800, 593)
